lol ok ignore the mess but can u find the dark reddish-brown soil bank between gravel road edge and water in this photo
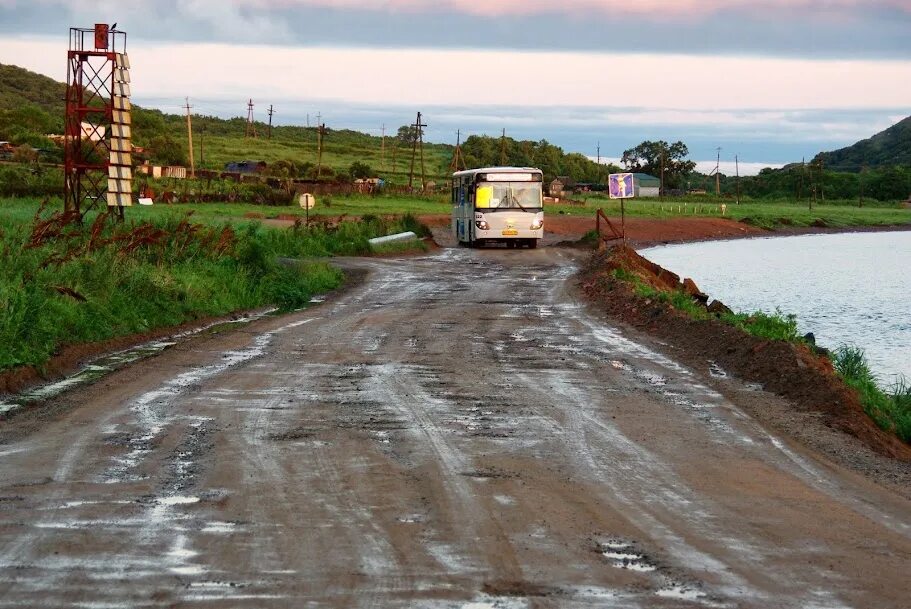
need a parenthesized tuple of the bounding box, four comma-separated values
(581, 247, 911, 461)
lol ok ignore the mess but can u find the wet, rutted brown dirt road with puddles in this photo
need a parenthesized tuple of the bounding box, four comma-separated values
(0, 250, 911, 608)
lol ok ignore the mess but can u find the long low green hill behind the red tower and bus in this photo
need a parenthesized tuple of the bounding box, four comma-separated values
(0, 65, 617, 184)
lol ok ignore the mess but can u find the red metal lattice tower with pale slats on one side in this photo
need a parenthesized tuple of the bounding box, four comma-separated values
(64, 24, 133, 218)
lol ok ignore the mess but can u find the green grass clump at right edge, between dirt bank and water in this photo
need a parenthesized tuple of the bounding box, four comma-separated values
(833, 345, 911, 443)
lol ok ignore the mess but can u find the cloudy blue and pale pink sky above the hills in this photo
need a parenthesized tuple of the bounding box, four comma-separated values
(0, 0, 911, 172)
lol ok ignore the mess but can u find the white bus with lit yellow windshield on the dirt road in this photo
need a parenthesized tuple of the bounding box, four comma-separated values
(452, 167, 544, 247)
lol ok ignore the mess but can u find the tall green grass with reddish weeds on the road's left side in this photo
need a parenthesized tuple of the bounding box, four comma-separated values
(0, 200, 422, 370)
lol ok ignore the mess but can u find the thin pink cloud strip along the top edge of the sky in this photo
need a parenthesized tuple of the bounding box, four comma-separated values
(253, 0, 911, 19)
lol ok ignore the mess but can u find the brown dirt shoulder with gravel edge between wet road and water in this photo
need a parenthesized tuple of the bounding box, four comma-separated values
(578, 250, 911, 496)
